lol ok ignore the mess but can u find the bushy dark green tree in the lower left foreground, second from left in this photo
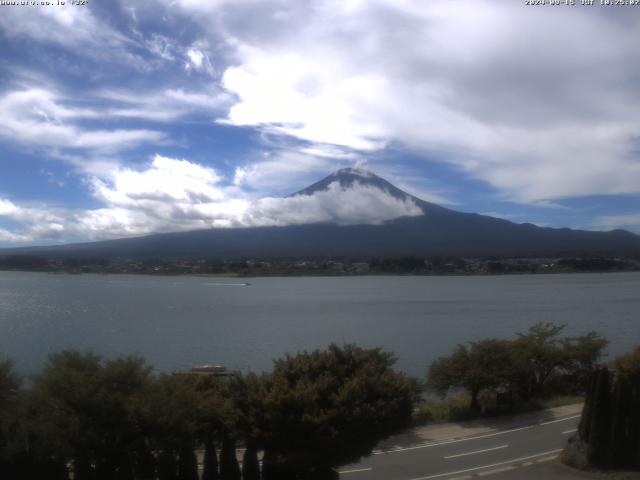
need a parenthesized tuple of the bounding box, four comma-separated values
(29, 351, 150, 480)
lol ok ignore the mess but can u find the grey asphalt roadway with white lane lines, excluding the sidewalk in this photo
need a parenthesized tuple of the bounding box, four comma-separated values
(340, 415, 580, 480)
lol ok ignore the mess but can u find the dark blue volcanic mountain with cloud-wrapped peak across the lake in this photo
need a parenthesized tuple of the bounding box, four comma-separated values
(0, 169, 640, 259)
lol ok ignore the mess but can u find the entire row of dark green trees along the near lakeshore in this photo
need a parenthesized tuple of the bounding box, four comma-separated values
(0, 323, 640, 480)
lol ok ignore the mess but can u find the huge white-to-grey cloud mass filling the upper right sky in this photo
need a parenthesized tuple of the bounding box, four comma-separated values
(172, 0, 640, 202)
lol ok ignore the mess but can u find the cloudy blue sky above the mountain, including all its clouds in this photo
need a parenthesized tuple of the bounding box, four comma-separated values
(0, 0, 640, 246)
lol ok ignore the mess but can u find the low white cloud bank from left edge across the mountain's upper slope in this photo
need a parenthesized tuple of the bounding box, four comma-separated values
(0, 155, 422, 242)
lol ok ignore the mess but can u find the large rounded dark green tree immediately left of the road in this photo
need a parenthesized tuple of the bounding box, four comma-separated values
(255, 345, 418, 480)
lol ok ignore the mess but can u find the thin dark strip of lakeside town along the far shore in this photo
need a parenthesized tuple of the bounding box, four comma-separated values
(0, 255, 640, 276)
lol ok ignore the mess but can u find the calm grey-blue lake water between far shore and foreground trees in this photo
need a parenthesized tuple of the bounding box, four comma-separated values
(0, 272, 640, 376)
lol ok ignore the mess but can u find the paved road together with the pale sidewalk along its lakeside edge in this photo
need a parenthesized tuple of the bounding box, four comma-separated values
(340, 404, 628, 480)
